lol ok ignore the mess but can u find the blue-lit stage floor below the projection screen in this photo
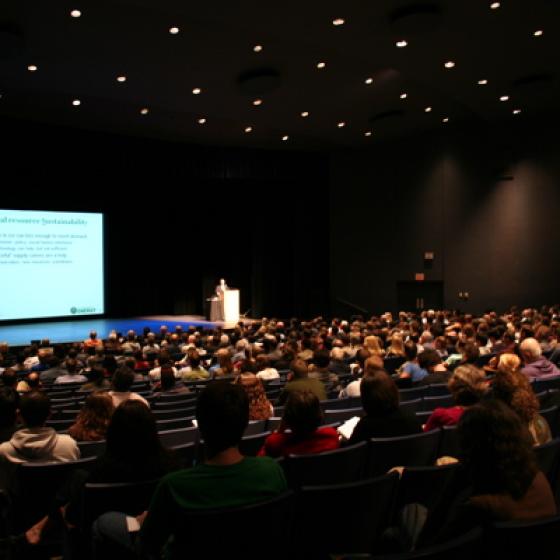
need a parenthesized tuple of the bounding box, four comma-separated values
(0, 315, 250, 346)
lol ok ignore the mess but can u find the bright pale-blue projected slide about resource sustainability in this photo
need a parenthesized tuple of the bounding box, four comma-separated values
(0, 210, 105, 321)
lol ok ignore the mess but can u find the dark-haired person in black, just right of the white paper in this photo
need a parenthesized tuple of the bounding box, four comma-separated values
(348, 370, 422, 445)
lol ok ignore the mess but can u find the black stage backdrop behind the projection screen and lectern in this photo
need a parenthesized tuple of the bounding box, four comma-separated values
(0, 119, 329, 317)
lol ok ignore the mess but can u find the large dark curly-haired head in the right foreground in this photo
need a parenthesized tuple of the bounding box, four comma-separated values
(458, 399, 538, 500)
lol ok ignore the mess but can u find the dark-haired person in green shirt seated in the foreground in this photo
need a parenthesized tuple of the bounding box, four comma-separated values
(94, 381, 287, 558)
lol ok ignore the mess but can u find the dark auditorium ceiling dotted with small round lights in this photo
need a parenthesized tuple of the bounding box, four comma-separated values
(0, 0, 560, 149)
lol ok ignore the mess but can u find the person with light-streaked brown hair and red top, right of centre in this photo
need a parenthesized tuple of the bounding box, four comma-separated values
(424, 364, 488, 432)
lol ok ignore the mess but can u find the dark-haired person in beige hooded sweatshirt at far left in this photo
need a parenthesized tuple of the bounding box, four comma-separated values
(0, 391, 80, 463)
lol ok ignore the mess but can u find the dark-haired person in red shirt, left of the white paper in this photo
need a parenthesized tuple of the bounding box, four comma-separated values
(259, 390, 340, 457)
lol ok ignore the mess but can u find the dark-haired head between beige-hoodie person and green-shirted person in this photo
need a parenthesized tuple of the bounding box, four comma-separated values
(107, 399, 161, 464)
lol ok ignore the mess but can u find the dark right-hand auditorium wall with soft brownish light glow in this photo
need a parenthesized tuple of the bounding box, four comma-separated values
(331, 119, 560, 313)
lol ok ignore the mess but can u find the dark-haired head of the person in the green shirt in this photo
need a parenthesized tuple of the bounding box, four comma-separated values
(196, 381, 249, 458)
